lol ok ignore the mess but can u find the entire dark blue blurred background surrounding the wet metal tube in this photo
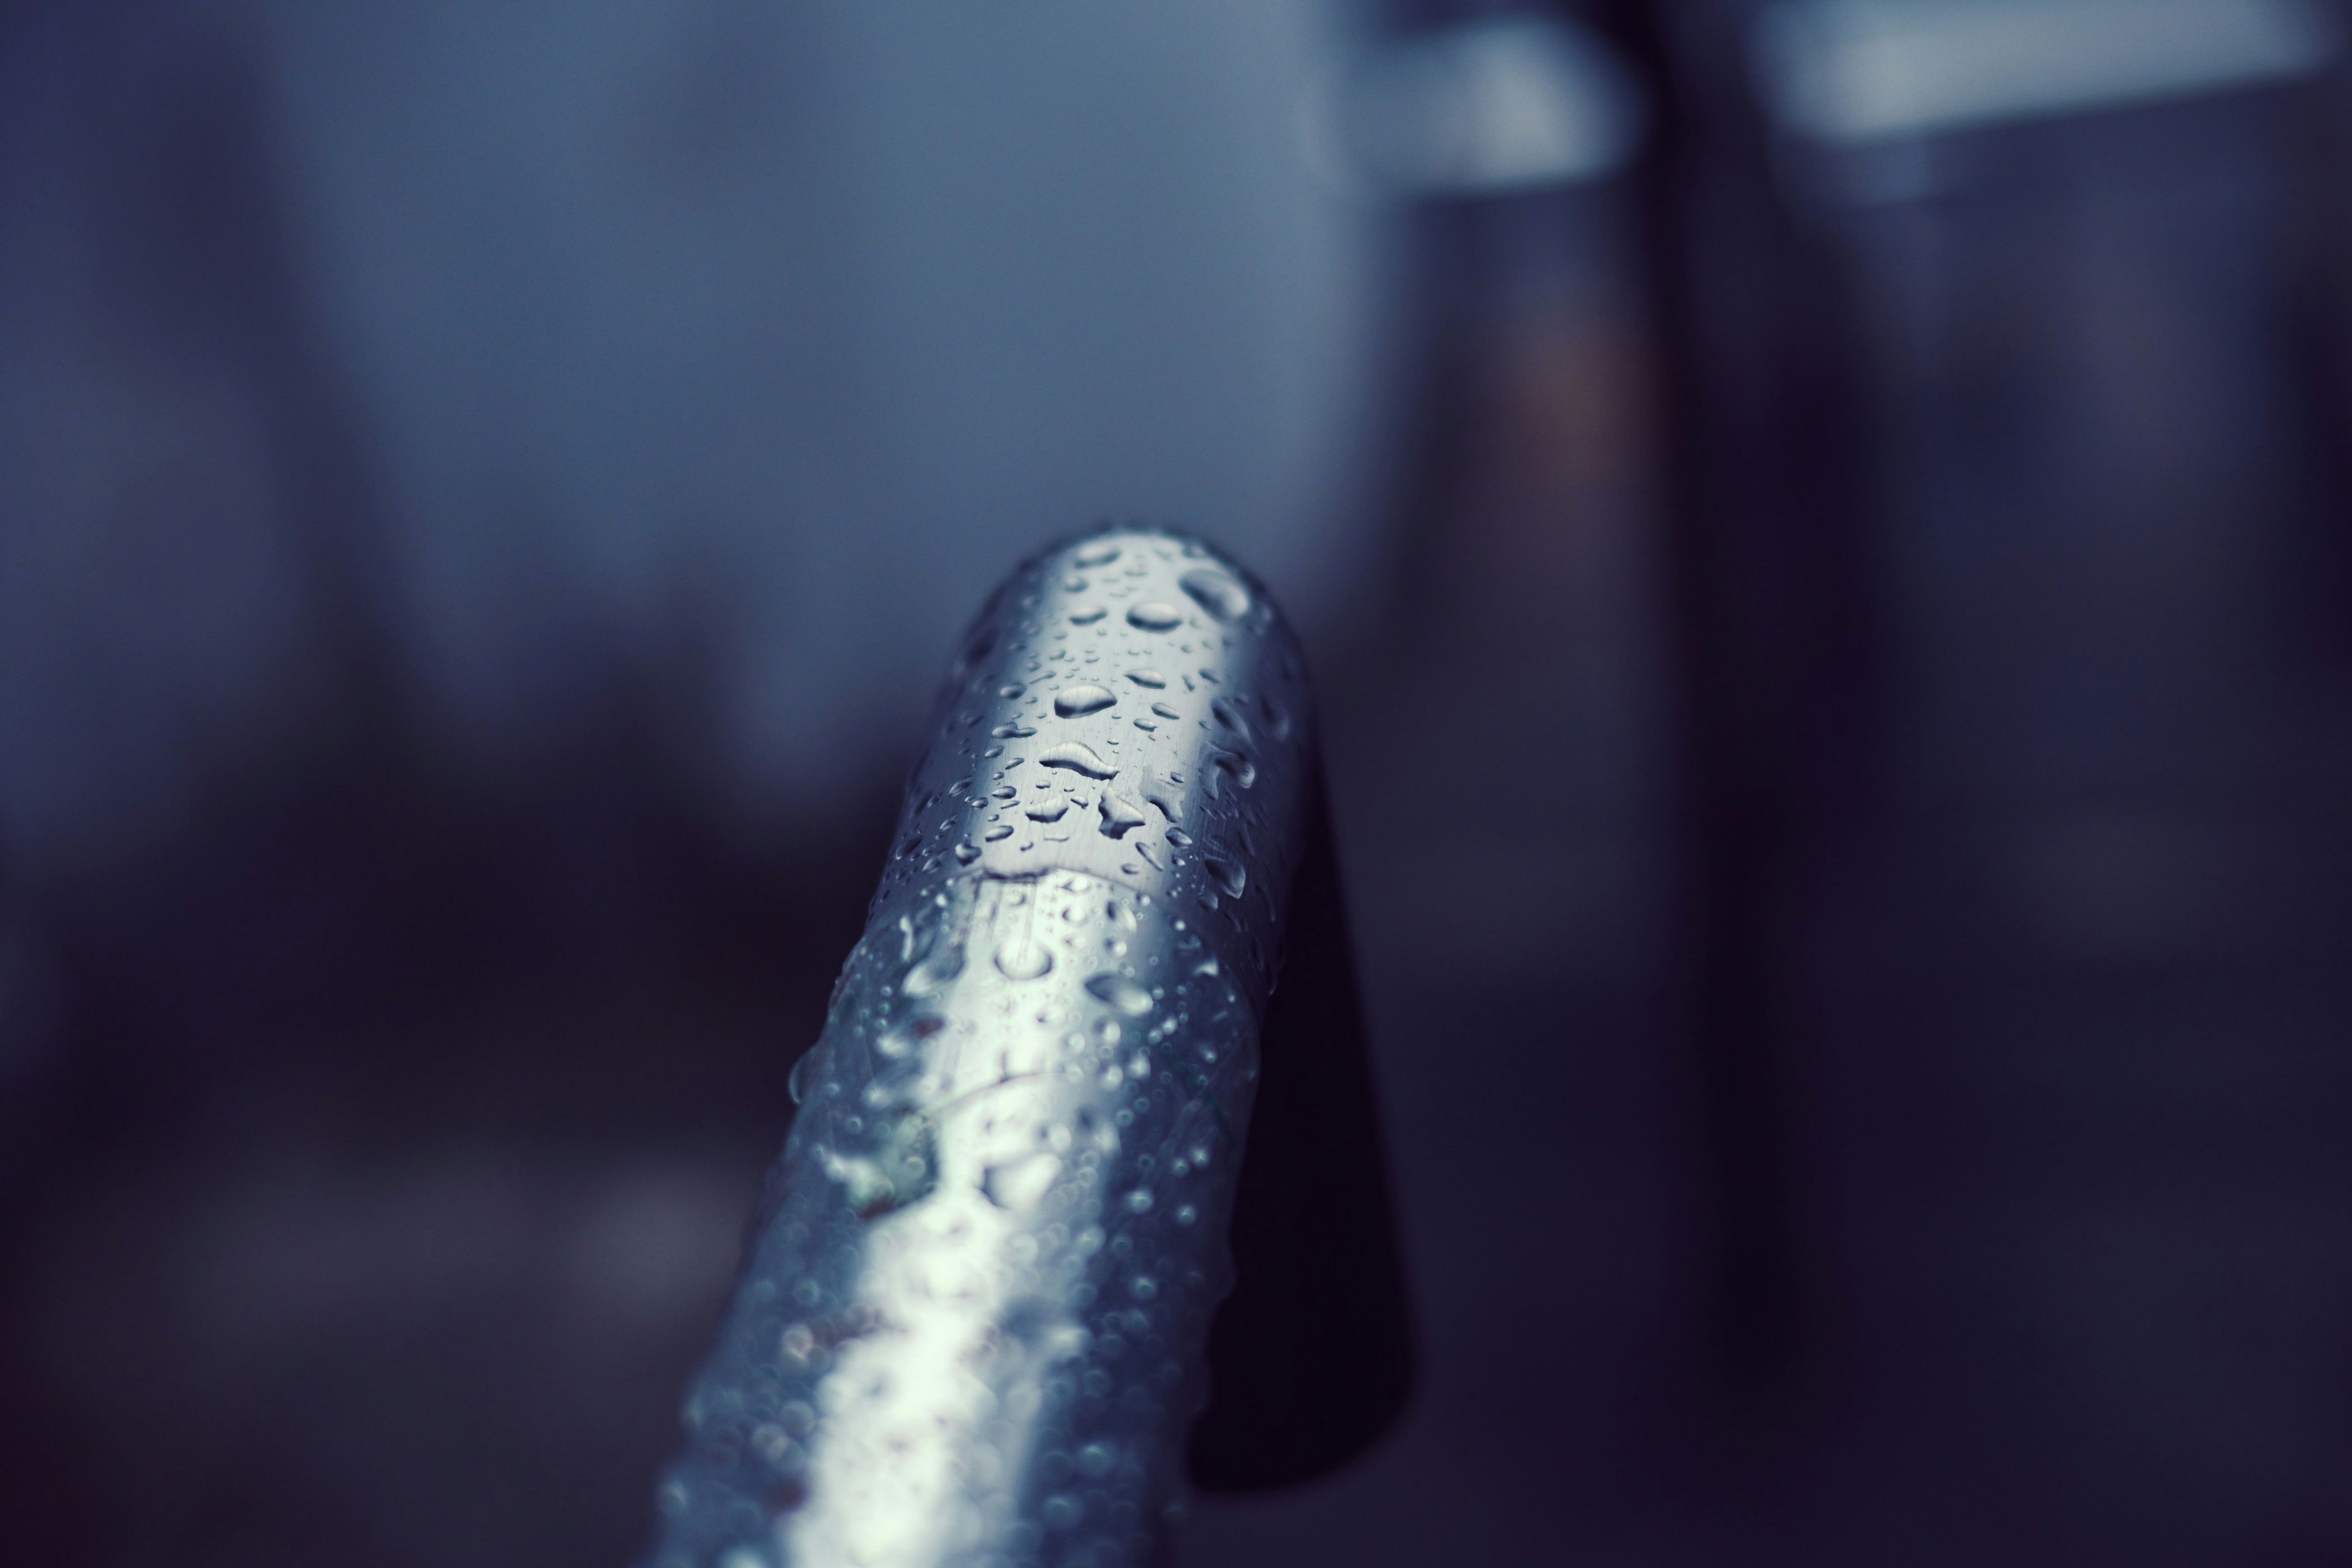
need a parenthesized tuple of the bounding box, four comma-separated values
(0, 0, 2352, 1568)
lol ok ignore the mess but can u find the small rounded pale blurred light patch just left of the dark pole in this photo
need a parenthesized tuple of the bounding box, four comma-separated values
(1313, 17, 1644, 195)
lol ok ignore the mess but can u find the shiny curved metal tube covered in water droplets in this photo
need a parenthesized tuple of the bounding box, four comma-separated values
(647, 529, 1313, 1568)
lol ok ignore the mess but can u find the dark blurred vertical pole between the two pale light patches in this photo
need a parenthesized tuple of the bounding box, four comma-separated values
(1595, 0, 1877, 1389)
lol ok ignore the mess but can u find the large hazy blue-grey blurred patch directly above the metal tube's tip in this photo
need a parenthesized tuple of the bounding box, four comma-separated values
(252, 0, 1395, 832)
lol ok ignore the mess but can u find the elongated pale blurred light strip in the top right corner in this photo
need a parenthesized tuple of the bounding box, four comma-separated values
(1757, 0, 2335, 143)
